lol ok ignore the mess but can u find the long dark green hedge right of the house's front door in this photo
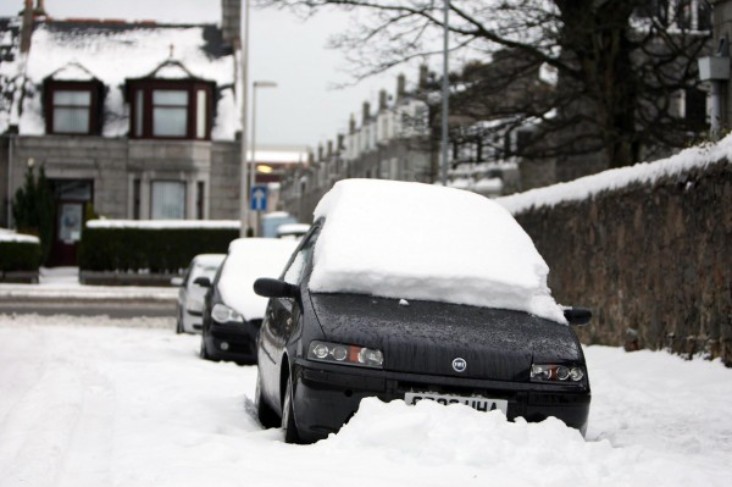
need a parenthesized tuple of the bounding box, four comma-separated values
(77, 226, 239, 273)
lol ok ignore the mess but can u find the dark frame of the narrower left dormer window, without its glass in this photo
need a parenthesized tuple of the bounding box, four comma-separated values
(43, 79, 104, 136)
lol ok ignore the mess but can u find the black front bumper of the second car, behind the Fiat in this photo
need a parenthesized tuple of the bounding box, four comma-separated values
(203, 323, 259, 363)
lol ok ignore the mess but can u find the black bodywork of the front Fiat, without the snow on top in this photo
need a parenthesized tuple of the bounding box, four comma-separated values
(254, 240, 590, 442)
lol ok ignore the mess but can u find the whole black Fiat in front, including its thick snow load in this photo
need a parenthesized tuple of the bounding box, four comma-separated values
(254, 180, 590, 442)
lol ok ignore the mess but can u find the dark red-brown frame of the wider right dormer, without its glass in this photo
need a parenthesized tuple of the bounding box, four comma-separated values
(127, 78, 216, 140)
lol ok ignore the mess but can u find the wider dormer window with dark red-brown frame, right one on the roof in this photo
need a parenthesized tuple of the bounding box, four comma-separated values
(127, 79, 215, 140)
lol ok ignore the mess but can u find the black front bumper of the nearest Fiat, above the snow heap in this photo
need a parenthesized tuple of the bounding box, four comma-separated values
(293, 360, 591, 441)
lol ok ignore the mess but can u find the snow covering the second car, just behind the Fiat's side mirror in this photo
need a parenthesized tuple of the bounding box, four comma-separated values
(218, 238, 298, 320)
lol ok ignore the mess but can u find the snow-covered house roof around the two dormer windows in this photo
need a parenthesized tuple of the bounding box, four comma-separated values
(0, 19, 240, 140)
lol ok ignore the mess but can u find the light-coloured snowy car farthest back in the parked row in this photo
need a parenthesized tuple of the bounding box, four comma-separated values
(171, 254, 226, 333)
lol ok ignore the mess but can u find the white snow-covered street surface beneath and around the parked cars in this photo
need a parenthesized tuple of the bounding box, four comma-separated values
(0, 315, 732, 487)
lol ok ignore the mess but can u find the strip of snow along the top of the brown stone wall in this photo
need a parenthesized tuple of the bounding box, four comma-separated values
(496, 135, 732, 214)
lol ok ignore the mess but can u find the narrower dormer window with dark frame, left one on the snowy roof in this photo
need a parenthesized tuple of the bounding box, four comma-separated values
(44, 79, 102, 135)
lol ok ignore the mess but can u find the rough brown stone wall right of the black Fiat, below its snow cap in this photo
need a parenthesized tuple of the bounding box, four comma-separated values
(515, 160, 732, 366)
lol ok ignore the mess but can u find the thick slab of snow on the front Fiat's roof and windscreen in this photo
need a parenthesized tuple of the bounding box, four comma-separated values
(310, 179, 566, 323)
